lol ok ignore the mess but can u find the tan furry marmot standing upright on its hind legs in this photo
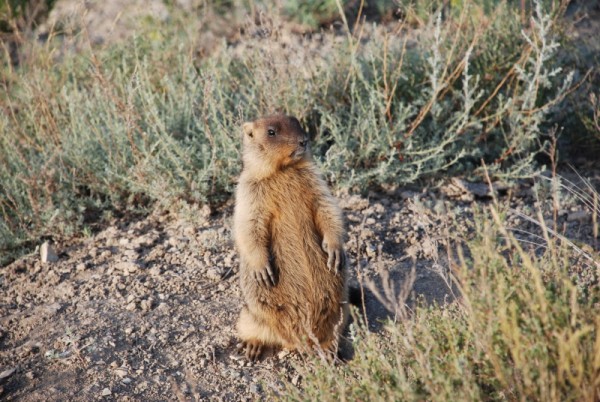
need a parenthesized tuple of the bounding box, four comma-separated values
(233, 115, 349, 360)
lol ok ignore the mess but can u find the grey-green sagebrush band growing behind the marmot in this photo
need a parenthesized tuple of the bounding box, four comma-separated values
(0, 2, 570, 264)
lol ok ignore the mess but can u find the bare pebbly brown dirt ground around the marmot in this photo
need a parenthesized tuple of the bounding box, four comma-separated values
(0, 171, 600, 401)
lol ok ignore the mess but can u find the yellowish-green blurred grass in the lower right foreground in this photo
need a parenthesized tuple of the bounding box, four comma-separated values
(285, 175, 600, 402)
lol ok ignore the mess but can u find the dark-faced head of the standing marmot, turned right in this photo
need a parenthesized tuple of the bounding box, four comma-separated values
(243, 115, 310, 173)
